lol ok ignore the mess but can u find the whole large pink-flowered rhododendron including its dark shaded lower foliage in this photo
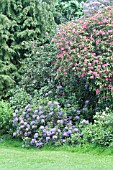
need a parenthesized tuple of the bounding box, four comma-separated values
(53, 7, 113, 118)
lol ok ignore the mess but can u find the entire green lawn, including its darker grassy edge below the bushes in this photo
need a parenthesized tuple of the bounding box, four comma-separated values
(0, 139, 113, 170)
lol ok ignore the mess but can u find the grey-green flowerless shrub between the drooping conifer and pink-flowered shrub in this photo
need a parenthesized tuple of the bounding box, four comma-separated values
(19, 39, 58, 96)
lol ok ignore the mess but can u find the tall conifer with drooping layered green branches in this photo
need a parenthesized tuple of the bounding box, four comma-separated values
(0, 0, 55, 98)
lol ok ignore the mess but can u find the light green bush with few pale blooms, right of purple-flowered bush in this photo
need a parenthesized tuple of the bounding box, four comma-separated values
(82, 108, 113, 146)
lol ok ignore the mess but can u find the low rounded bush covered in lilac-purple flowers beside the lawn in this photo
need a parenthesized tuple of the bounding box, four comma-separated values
(13, 98, 89, 147)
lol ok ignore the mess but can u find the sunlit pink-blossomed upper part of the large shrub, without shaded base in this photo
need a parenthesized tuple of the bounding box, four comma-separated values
(55, 7, 113, 99)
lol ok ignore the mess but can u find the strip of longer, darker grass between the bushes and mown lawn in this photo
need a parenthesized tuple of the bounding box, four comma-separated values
(0, 138, 113, 155)
